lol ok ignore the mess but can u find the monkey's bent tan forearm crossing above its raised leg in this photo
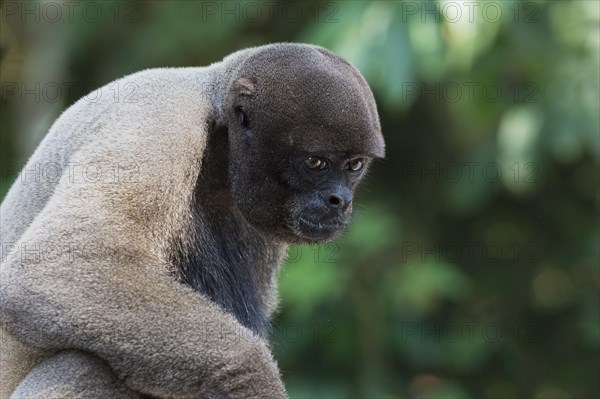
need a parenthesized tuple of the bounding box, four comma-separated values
(2, 253, 286, 398)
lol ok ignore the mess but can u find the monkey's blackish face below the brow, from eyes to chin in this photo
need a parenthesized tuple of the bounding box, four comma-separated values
(231, 141, 371, 243)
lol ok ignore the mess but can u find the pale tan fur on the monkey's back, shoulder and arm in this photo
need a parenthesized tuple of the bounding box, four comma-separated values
(0, 61, 285, 398)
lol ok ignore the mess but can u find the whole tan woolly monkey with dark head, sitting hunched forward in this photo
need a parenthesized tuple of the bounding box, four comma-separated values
(0, 43, 384, 399)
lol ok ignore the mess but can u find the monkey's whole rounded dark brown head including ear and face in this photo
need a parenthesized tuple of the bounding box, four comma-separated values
(226, 44, 384, 243)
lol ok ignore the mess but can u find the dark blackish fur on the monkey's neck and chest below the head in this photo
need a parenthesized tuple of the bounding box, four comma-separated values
(173, 122, 285, 336)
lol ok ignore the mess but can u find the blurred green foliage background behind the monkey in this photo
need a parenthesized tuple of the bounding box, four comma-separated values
(0, 0, 600, 399)
